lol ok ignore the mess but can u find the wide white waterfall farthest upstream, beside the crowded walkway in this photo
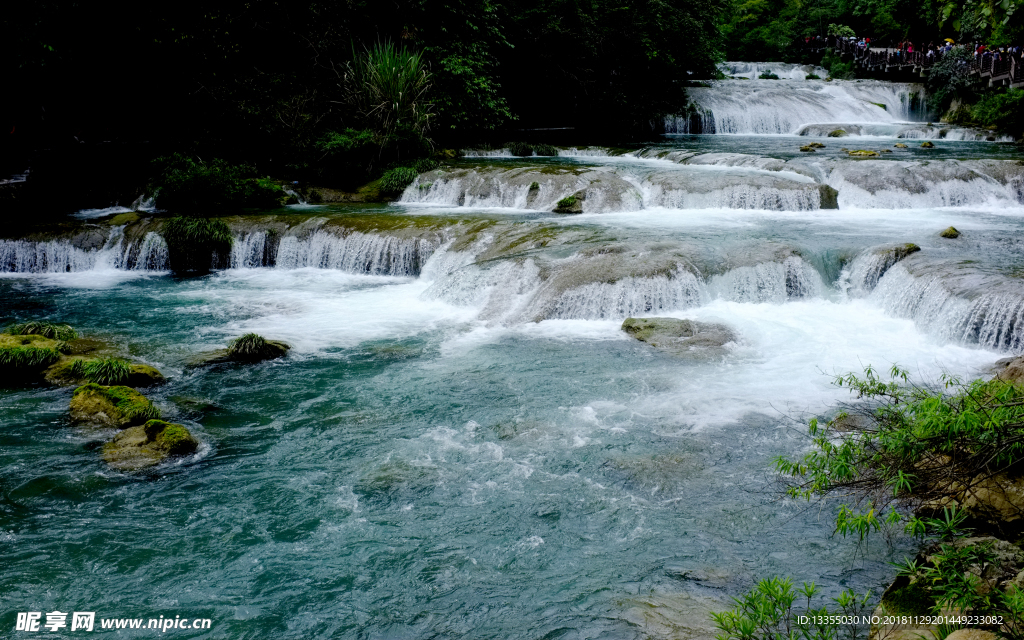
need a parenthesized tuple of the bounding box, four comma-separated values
(665, 80, 924, 134)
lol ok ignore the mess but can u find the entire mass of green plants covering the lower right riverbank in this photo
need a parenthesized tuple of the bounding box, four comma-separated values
(714, 367, 1024, 640)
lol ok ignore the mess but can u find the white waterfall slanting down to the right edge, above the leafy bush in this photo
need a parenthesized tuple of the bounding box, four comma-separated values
(871, 264, 1024, 352)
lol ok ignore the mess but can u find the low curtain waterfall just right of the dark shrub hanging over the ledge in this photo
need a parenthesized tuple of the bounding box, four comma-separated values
(274, 230, 435, 275)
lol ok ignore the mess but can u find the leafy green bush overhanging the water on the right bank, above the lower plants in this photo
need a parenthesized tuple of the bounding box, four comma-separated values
(776, 367, 1024, 539)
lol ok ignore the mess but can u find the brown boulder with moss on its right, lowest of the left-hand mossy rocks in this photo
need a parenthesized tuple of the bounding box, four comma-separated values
(103, 420, 199, 471)
